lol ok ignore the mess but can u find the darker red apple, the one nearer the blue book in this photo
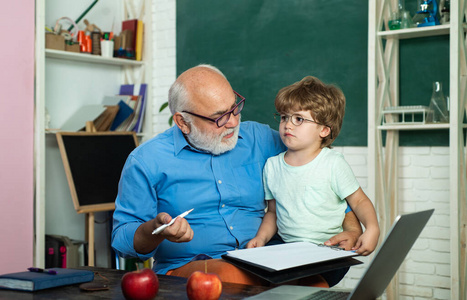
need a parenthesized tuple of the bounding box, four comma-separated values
(122, 268, 159, 300)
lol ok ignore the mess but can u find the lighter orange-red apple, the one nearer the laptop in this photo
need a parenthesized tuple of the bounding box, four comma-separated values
(186, 271, 222, 300)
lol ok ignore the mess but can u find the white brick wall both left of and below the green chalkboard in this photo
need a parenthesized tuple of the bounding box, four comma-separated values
(152, 0, 450, 299)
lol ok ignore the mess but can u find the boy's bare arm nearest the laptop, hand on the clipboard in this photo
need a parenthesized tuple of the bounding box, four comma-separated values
(346, 188, 379, 255)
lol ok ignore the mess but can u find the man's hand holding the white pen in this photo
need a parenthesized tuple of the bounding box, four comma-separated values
(153, 212, 193, 243)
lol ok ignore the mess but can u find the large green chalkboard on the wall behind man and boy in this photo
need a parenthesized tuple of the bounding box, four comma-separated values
(176, 0, 449, 146)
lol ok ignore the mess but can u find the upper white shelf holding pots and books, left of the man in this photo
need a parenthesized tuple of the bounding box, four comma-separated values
(45, 49, 144, 66)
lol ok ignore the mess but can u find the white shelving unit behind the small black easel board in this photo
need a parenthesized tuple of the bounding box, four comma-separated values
(34, 0, 153, 267)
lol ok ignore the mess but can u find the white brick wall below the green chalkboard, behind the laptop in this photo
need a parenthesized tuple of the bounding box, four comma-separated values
(335, 147, 450, 299)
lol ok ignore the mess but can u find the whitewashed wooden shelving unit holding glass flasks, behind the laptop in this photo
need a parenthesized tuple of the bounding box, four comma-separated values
(368, 0, 467, 299)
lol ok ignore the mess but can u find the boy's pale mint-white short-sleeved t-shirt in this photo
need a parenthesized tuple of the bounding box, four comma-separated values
(263, 148, 360, 243)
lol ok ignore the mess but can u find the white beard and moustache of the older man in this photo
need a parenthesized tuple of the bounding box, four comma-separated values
(186, 119, 240, 155)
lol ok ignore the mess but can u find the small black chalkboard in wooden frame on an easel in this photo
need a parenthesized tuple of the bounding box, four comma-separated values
(57, 132, 138, 213)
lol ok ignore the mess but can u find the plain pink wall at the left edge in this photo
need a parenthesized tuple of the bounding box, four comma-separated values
(0, 0, 35, 274)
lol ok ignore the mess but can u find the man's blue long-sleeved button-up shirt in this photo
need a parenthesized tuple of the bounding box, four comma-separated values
(112, 122, 285, 274)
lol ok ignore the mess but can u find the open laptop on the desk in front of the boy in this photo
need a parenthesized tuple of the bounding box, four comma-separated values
(248, 209, 434, 300)
